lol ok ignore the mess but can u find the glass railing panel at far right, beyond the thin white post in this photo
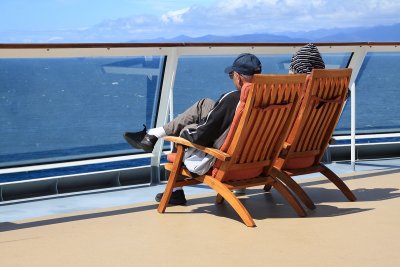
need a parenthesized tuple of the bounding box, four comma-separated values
(356, 53, 400, 134)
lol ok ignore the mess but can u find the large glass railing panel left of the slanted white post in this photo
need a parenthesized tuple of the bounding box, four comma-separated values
(0, 57, 164, 167)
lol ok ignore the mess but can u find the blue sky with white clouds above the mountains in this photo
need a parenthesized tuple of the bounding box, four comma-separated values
(0, 0, 400, 43)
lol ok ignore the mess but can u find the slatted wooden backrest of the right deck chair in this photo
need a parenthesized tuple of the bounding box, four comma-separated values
(286, 69, 352, 169)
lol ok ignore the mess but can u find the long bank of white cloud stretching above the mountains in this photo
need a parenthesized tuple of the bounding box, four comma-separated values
(84, 0, 400, 40)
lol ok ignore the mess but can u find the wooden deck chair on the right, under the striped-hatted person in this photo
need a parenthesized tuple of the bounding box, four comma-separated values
(265, 69, 356, 209)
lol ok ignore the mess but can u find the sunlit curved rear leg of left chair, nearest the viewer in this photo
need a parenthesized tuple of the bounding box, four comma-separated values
(204, 176, 256, 227)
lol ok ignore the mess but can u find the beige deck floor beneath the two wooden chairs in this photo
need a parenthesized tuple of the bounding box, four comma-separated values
(0, 169, 400, 266)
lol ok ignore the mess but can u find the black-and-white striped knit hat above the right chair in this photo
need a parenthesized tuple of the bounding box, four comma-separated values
(289, 43, 325, 73)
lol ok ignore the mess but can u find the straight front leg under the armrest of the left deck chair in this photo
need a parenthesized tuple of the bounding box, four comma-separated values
(157, 145, 184, 213)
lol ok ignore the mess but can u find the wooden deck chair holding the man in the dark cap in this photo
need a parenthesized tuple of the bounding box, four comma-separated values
(158, 74, 306, 226)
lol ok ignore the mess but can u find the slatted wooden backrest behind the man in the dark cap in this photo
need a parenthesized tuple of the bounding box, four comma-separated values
(213, 74, 306, 180)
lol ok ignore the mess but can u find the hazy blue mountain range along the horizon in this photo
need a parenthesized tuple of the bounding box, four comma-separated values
(131, 23, 400, 43)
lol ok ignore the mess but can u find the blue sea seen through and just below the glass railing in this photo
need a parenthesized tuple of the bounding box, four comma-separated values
(0, 53, 400, 182)
